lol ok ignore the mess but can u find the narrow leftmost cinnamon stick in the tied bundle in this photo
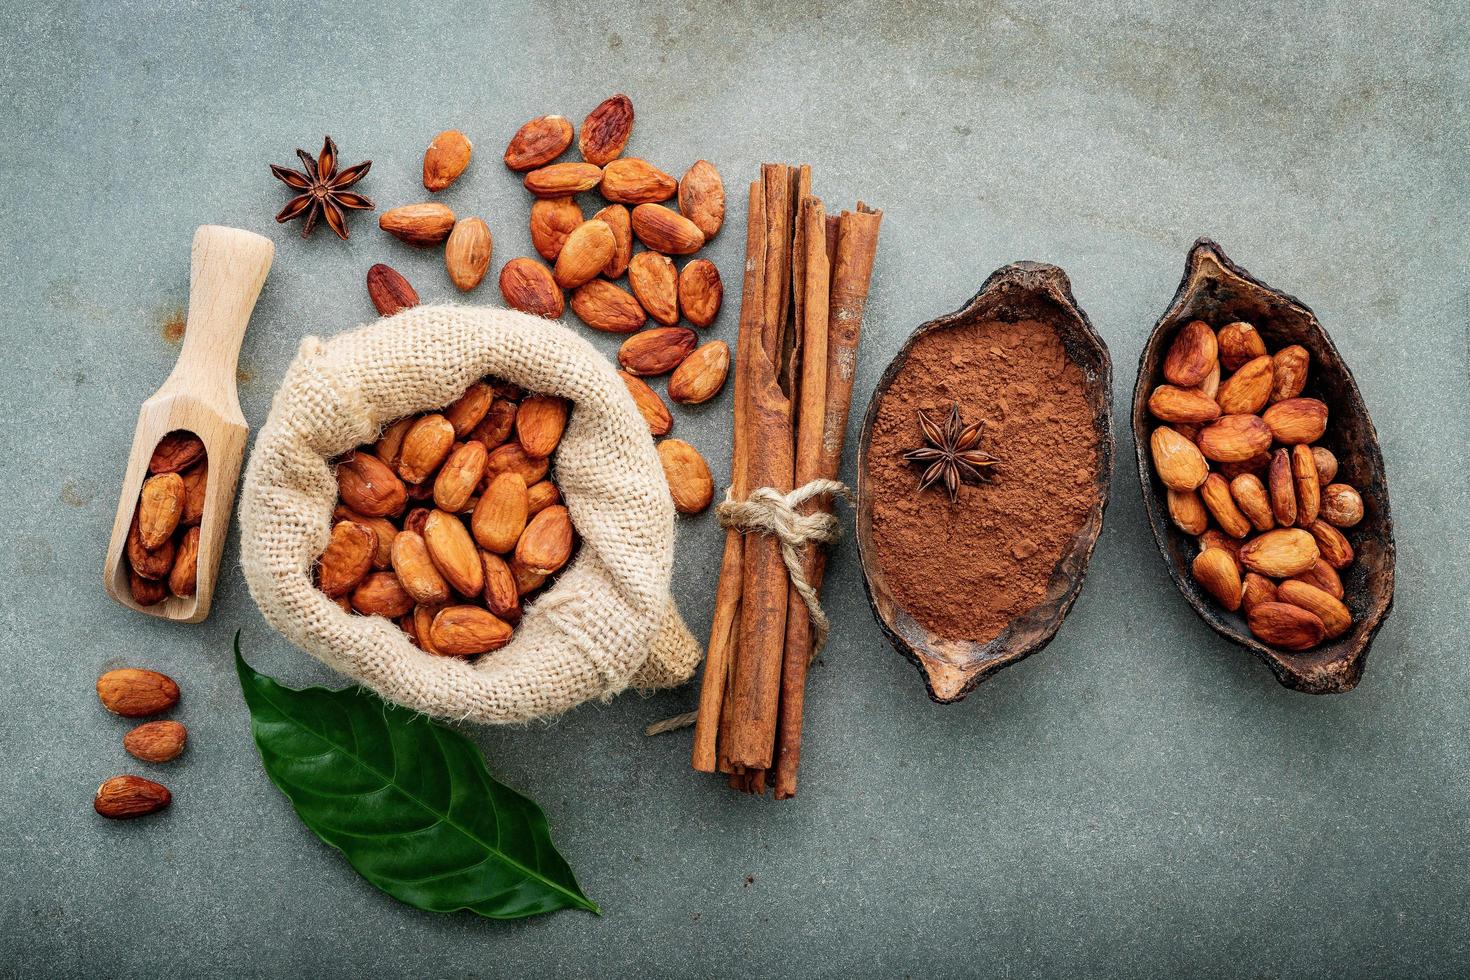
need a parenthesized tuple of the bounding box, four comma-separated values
(692, 181, 766, 773)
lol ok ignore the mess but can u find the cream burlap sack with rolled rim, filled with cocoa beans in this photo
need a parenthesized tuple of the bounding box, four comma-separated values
(240, 306, 701, 723)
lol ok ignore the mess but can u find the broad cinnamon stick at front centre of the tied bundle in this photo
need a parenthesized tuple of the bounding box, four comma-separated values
(722, 165, 794, 768)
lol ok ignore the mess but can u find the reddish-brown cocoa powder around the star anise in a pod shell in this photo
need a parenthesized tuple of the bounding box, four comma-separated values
(866, 320, 1098, 644)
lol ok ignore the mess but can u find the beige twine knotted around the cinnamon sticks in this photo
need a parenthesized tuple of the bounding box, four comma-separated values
(644, 479, 853, 735)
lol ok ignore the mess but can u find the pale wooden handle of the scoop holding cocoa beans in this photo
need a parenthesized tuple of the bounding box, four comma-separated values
(159, 225, 275, 408)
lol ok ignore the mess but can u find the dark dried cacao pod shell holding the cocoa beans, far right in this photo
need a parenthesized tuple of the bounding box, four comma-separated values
(1133, 238, 1394, 693)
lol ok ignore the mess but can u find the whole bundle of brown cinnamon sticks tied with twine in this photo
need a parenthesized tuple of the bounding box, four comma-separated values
(692, 163, 882, 799)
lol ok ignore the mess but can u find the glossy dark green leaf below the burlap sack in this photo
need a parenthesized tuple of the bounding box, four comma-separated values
(235, 633, 598, 918)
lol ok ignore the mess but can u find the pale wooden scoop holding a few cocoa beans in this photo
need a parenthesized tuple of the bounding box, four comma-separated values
(103, 225, 275, 623)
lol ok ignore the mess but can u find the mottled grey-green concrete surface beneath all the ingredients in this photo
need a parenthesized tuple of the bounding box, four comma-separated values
(0, 0, 1470, 977)
